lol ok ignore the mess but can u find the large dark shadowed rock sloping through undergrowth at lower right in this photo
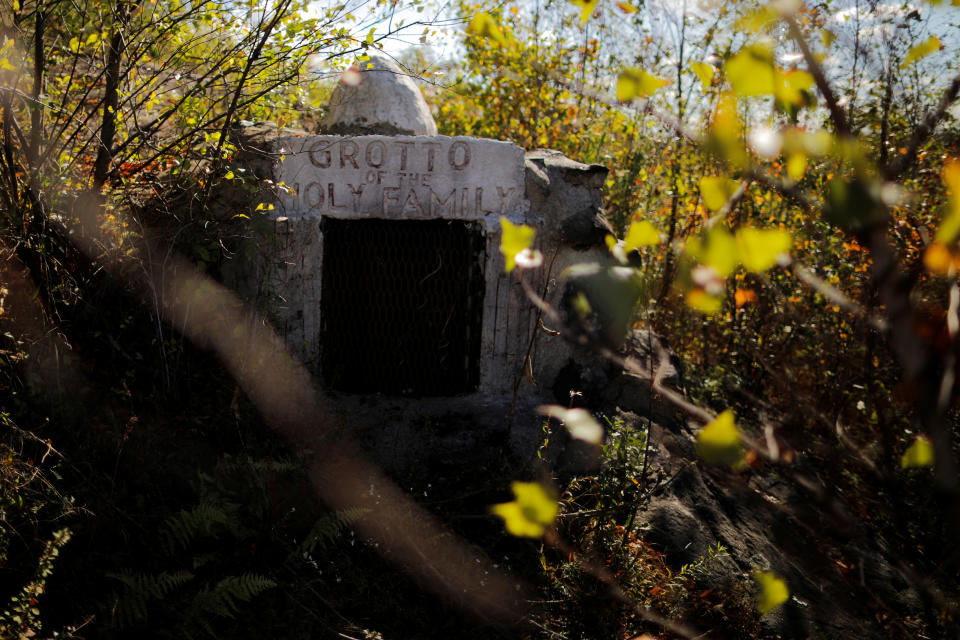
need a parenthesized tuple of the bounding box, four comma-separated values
(636, 421, 920, 638)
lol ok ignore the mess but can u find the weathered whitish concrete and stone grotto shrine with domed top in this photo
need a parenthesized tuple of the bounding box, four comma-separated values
(225, 58, 610, 464)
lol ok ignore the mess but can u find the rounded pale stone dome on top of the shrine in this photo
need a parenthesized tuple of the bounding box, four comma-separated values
(320, 56, 437, 136)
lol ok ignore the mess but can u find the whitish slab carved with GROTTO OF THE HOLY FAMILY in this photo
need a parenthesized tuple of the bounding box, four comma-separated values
(280, 136, 524, 219)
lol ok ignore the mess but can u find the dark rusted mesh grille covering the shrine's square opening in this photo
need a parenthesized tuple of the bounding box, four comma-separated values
(320, 218, 484, 396)
